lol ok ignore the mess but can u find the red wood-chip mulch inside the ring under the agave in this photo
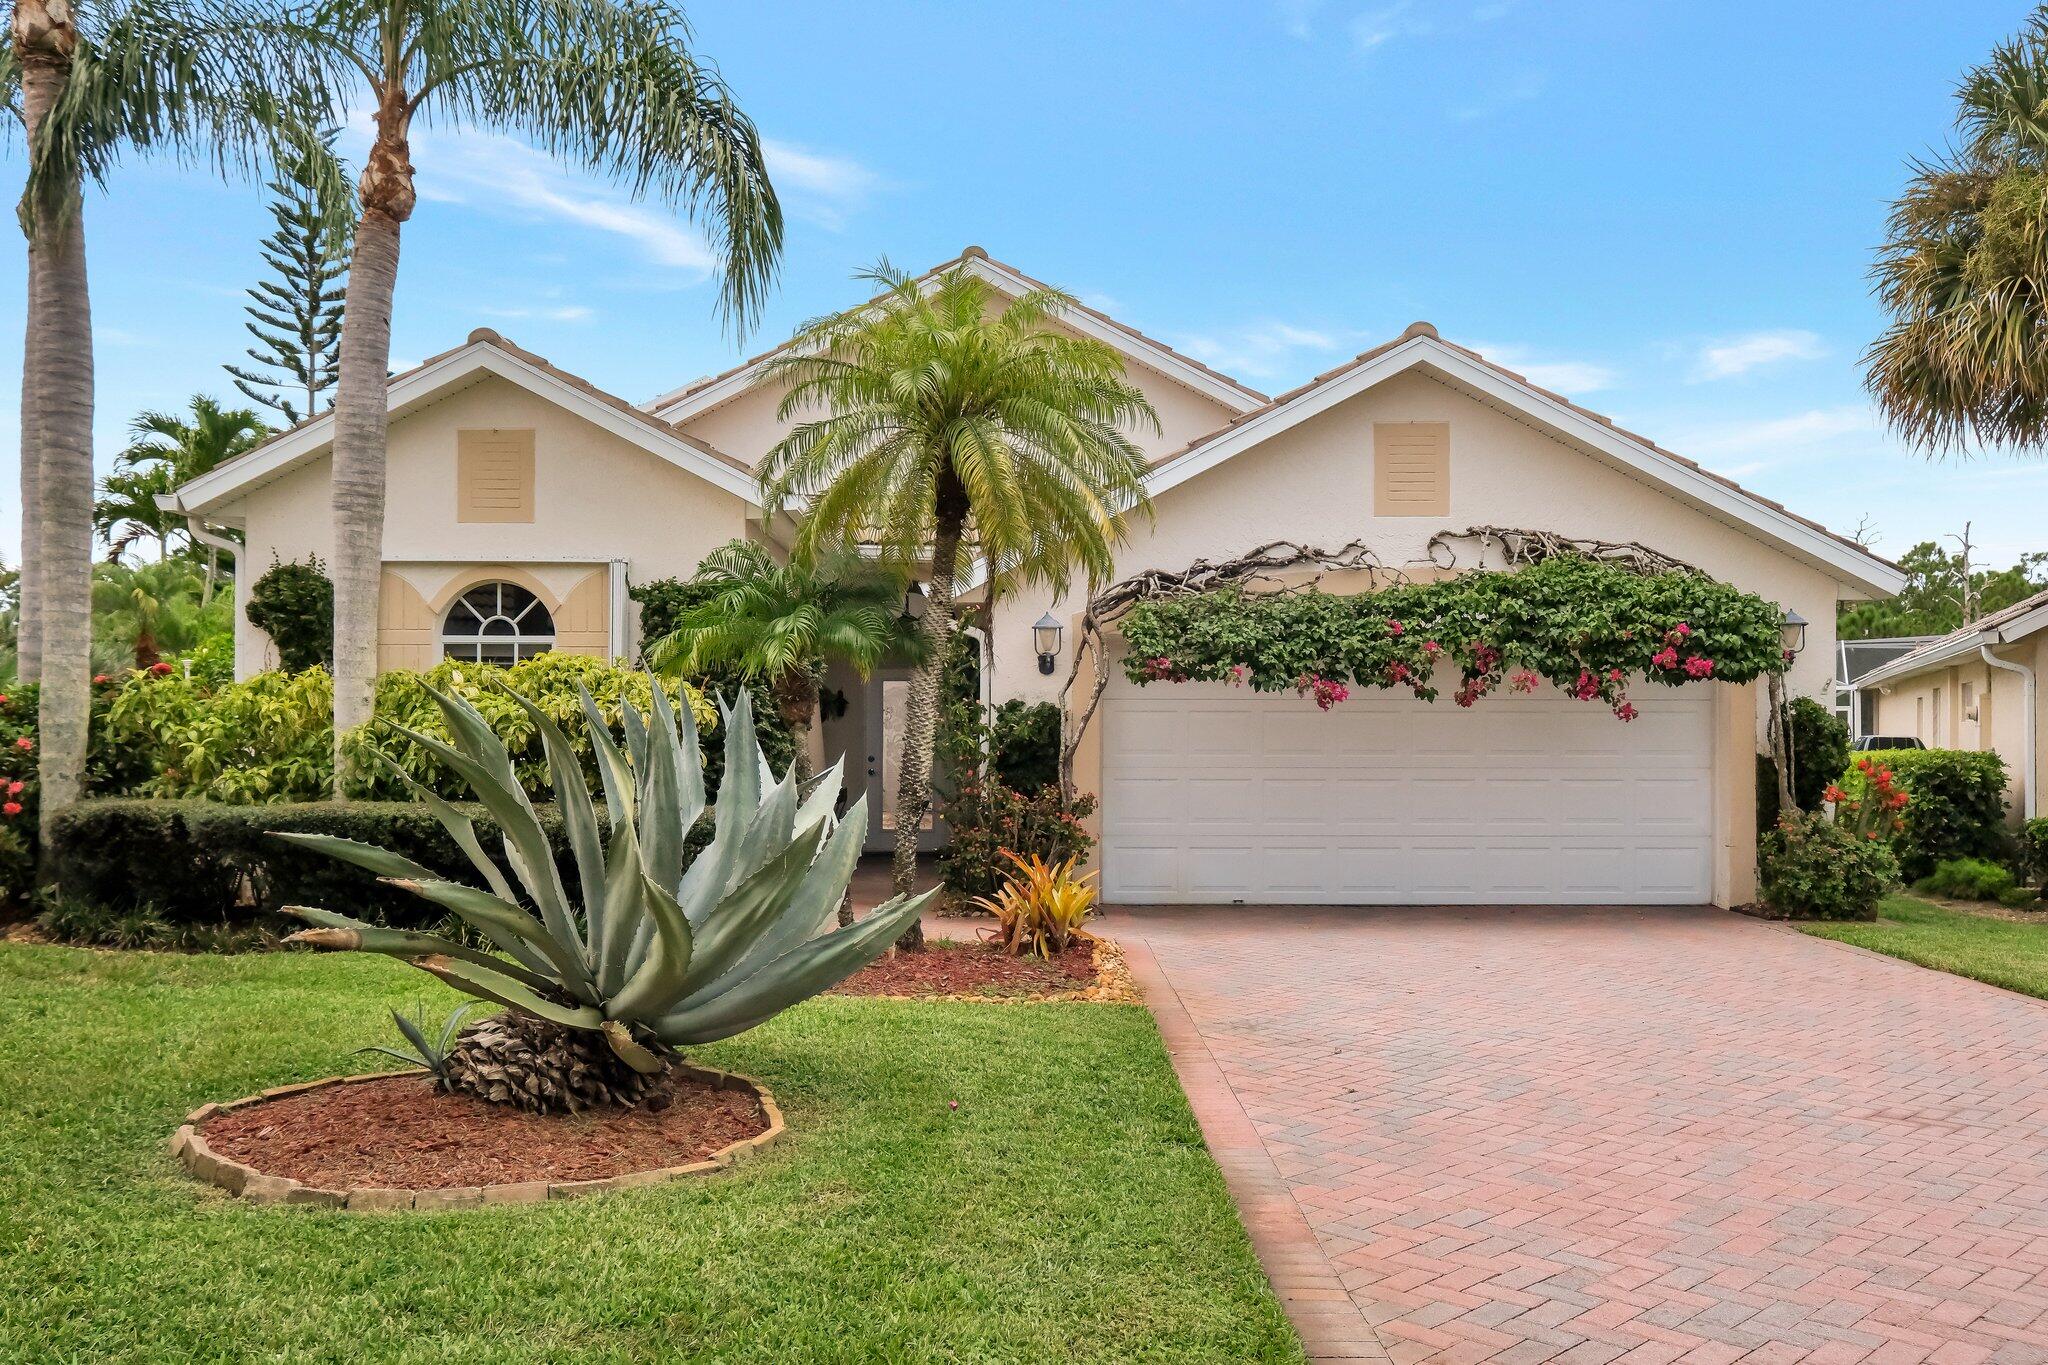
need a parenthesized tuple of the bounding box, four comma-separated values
(201, 1074, 768, 1189)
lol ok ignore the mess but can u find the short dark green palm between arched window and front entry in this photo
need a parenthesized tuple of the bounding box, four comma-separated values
(645, 540, 903, 780)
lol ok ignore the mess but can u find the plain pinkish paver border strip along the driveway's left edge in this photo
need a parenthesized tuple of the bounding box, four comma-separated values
(1120, 925, 1393, 1363)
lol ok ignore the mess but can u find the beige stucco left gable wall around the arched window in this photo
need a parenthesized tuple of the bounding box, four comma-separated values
(221, 379, 748, 675)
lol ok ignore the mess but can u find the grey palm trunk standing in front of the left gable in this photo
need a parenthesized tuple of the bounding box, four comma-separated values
(330, 106, 414, 794)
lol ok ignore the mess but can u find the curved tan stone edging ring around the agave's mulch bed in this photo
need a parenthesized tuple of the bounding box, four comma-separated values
(170, 1062, 786, 1214)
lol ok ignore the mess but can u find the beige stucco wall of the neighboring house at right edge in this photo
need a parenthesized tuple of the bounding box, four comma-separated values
(1874, 636, 2048, 821)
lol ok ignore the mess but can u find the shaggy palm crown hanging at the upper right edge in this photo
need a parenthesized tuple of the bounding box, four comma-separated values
(1864, 10, 2048, 454)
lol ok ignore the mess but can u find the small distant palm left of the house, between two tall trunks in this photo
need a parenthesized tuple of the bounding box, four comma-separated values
(92, 393, 270, 600)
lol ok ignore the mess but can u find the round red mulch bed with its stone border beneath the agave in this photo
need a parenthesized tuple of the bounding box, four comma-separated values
(172, 1064, 782, 1209)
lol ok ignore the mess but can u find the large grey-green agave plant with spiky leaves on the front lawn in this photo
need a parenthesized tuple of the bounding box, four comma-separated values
(276, 686, 930, 1109)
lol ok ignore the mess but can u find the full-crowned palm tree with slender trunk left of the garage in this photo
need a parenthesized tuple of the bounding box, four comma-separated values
(762, 262, 1159, 948)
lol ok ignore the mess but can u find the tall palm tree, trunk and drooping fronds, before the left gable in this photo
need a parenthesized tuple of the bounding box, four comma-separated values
(250, 0, 782, 782)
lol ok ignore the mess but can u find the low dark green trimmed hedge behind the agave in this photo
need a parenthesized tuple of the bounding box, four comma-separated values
(45, 798, 711, 929)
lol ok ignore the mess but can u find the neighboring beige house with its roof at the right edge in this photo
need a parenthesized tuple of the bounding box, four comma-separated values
(1855, 591, 2048, 819)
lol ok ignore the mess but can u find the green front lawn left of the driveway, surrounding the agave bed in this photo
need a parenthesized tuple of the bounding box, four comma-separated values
(0, 945, 1303, 1365)
